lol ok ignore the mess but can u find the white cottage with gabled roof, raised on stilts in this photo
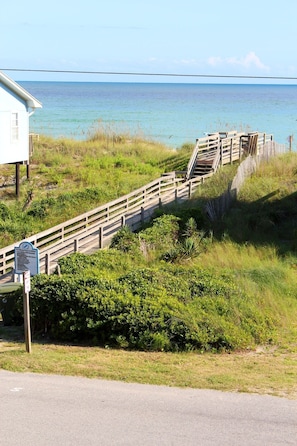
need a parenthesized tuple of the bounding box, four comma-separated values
(0, 72, 42, 164)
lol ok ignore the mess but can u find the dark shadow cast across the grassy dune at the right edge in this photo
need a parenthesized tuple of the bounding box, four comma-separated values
(153, 190, 297, 256)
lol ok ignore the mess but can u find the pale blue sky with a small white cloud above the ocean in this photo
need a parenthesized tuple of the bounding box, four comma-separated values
(0, 0, 297, 84)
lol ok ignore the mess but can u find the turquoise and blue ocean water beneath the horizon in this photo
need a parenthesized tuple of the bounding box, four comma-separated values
(19, 81, 297, 148)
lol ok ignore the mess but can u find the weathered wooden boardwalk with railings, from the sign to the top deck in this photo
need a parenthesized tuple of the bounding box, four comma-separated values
(0, 134, 280, 275)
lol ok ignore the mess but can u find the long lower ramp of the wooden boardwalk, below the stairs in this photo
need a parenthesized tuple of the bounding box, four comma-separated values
(0, 172, 208, 275)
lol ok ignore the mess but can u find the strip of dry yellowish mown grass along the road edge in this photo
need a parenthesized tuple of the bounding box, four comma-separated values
(0, 336, 297, 399)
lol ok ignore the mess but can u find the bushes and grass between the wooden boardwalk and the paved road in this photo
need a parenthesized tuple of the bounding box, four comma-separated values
(0, 140, 297, 397)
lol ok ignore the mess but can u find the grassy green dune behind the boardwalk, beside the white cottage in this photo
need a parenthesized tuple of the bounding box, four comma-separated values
(0, 132, 191, 247)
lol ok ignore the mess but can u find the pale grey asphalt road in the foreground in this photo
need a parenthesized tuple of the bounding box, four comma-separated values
(0, 370, 297, 446)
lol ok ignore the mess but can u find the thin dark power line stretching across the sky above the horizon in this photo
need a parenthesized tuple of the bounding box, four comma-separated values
(0, 68, 297, 80)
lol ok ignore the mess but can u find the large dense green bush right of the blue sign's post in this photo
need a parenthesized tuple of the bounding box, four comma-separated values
(15, 264, 274, 351)
